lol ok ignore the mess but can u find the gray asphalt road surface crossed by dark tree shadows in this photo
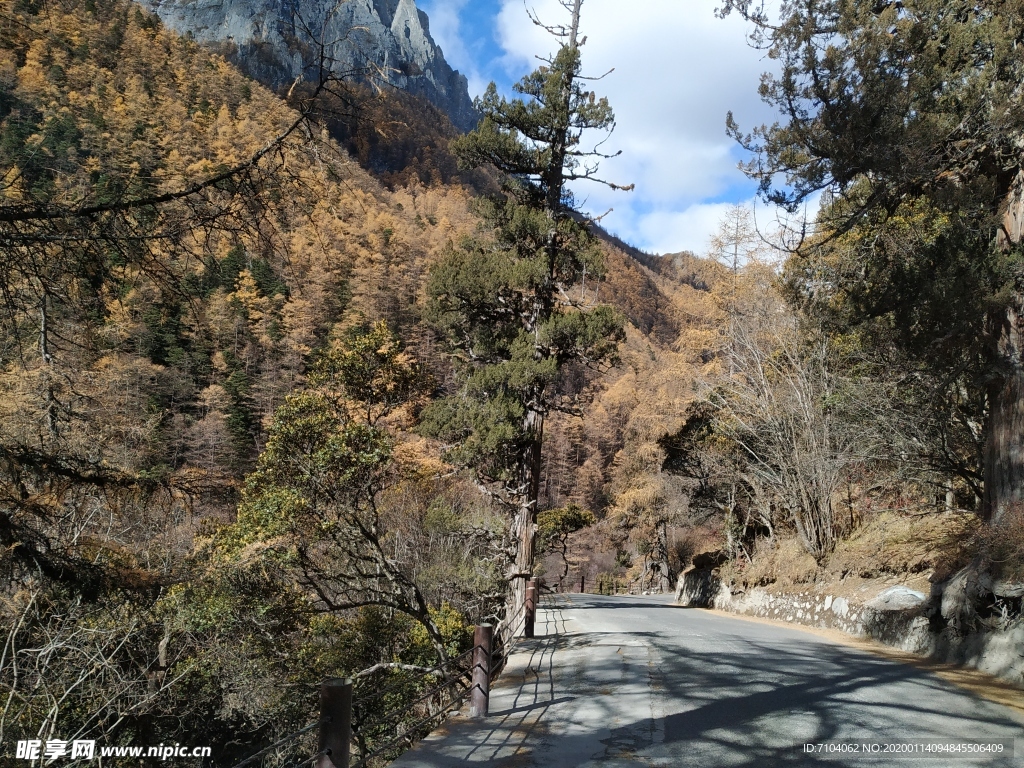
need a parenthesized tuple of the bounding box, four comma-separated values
(394, 595, 1024, 768)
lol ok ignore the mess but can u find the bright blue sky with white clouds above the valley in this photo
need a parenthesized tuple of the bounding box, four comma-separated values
(418, 0, 790, 259)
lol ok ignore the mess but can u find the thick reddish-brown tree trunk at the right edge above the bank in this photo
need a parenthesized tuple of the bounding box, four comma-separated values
(982, 306, 1024, 523)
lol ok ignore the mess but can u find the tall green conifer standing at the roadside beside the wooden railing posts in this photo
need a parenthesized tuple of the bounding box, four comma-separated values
(424, 0, 632, 614)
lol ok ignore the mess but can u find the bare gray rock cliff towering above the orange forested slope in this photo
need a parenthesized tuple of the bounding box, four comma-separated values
(141, 0, 477, 131)
